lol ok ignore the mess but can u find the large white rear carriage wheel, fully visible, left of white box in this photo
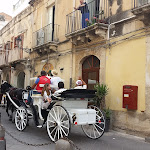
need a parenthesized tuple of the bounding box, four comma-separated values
(47, 105, 71, 142)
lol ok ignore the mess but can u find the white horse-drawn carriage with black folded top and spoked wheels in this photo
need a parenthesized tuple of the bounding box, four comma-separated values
(6, 86, 105, 142)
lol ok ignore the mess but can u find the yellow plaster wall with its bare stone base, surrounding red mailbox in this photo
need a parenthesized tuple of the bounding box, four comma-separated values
(106, 32, 150, 136)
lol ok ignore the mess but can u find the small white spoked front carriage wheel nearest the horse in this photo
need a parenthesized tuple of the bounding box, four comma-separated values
(15, 107, 28, 131)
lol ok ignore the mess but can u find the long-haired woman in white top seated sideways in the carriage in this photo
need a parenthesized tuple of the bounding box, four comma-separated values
(41, 83, 52, 109)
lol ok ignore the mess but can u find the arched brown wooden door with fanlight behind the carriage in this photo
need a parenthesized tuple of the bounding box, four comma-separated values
(82, 55, 100, 90)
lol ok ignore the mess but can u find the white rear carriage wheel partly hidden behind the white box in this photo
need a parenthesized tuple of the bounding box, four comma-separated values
(82, 106, 105, 139)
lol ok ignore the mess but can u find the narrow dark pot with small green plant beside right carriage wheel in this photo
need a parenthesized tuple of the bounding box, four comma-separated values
(104, 107, 111, 132)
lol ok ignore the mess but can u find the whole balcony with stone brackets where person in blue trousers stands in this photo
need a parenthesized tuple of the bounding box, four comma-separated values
(66, 0, 110, 45)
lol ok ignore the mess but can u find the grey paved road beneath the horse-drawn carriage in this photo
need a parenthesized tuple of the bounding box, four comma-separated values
(0, 107, 150, 150)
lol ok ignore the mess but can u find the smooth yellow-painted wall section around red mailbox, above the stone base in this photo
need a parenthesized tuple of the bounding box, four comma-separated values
(106, 37, 146, 112)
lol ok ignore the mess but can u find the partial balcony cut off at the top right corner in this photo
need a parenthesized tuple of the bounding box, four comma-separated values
(132, 0, 150, 25)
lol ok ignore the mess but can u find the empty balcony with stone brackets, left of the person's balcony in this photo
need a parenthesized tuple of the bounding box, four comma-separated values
(33, 24, 59, 54)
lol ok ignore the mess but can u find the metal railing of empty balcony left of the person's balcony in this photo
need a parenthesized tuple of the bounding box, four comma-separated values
(33, 24, 59, 47)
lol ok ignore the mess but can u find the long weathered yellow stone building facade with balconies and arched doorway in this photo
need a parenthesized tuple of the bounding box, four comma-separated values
(0, 0, 150, 136)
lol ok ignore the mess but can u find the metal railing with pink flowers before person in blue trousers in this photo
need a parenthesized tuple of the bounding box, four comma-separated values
(66, 0, 110, 35)
